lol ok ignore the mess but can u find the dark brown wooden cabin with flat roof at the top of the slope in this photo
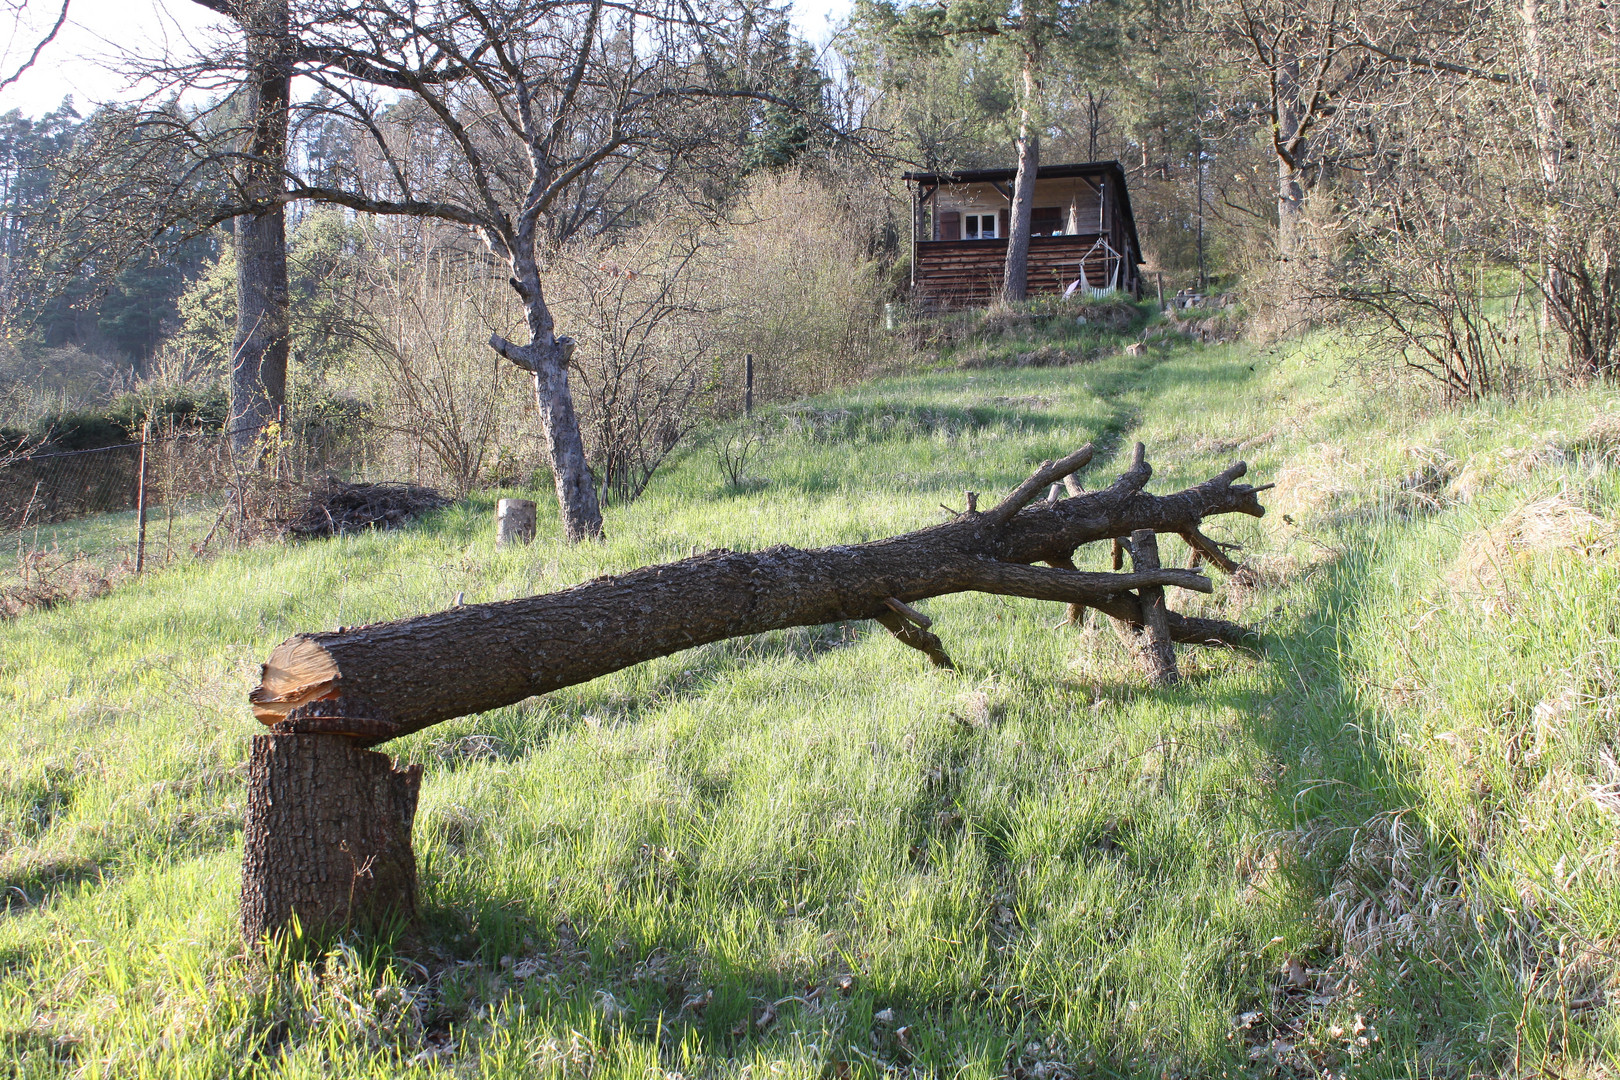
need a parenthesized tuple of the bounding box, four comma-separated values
(904, 162, 1142, 308)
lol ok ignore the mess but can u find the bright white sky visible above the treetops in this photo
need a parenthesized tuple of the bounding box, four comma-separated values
(0, 0, 851, 117)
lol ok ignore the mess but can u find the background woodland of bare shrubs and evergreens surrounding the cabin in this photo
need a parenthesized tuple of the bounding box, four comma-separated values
(0, 0, 1620, 499)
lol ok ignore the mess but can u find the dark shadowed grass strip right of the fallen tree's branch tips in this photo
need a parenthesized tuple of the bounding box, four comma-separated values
(1244, 544, 1520, 1075)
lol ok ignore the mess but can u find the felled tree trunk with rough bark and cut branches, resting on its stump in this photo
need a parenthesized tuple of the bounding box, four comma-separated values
(251, 447, 1264, 742)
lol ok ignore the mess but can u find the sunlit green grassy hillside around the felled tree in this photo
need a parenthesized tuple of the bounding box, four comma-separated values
(0, 320, 1620, 1080)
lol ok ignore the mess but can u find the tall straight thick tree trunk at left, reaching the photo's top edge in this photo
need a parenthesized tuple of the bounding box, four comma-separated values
(230, 0, 293, 453)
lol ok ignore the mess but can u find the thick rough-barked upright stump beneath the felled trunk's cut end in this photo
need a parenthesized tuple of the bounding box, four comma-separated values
(241, 733, 421, 942)
